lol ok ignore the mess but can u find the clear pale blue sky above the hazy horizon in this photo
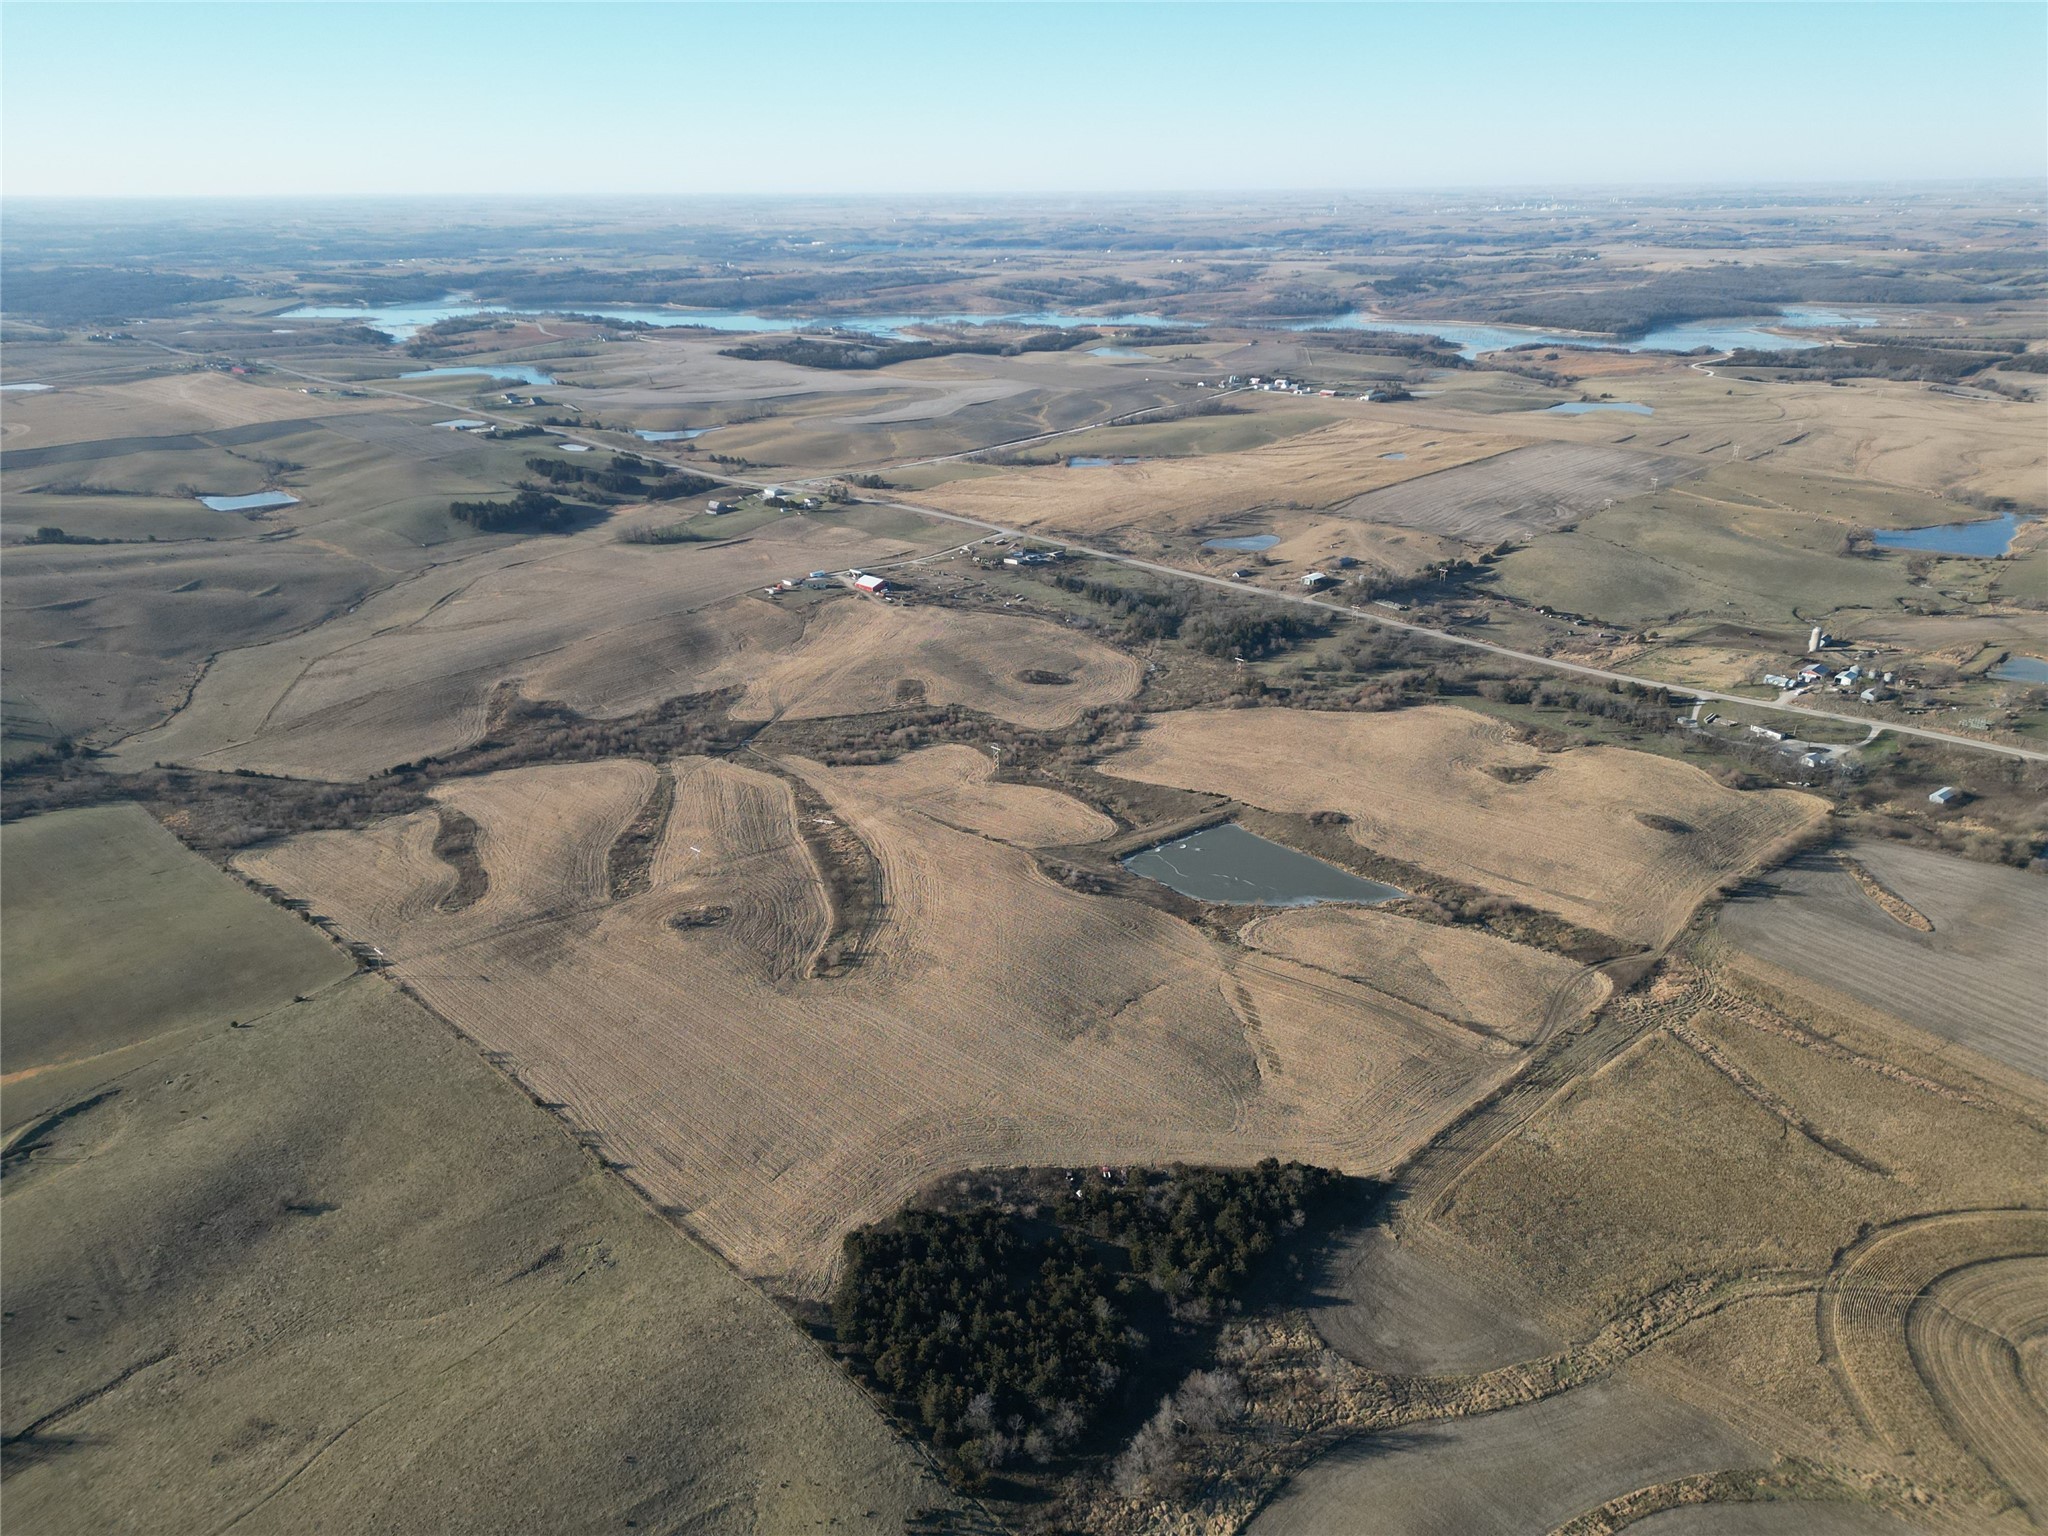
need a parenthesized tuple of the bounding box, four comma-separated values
(0, 0, 2048, 197)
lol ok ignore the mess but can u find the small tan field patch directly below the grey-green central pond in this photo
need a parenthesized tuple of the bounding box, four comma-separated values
(1241, 907, 1610, 1042)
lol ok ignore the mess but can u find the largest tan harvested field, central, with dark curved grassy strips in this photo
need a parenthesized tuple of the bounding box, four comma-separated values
(242, 752, 1511, 1294)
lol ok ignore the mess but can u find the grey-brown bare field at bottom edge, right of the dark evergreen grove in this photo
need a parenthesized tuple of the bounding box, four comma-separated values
(1247, 1376, 1767, 1536)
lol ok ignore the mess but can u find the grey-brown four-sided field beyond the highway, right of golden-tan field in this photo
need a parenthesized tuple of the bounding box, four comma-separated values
(1339, 442, 1698, 545)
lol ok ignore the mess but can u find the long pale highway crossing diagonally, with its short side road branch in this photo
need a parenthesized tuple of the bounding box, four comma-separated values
(192, 342, 2048, 762)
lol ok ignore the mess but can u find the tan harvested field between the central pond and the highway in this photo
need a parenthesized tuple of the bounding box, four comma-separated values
(1104, 705, 1827, 946)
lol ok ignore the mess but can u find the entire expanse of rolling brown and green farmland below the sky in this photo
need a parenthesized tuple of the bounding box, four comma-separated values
(0, 188, 2048, 1536)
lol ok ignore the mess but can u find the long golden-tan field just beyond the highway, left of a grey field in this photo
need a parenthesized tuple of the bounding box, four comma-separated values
(918, 418, 1511, 539)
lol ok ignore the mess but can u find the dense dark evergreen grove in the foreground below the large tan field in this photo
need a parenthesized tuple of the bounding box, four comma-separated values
(834, 1159, 1337, 1483)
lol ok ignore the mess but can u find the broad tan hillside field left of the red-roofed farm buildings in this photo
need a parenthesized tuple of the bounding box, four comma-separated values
(103, 518, 950, 778)
